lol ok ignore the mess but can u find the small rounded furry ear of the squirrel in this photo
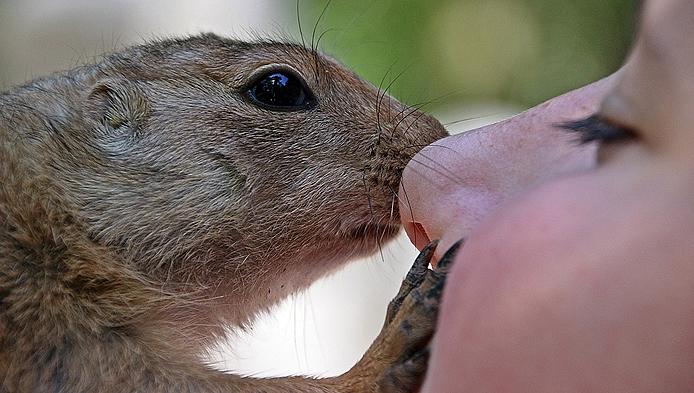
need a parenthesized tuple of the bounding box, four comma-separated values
(85, 79, 149, 131)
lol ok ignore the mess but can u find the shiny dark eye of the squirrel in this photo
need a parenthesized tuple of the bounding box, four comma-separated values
(247, 71, 313, 111)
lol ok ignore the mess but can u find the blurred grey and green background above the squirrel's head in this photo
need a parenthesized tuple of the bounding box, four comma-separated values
(0, 0, 635, 110)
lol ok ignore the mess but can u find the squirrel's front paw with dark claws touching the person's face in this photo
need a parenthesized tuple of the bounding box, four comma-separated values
(332, 241, 462, 393)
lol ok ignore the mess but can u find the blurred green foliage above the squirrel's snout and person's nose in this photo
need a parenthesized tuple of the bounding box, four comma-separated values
(299, 0, 636, 106)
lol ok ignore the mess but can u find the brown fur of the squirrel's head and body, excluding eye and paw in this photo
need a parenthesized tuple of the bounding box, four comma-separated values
(0, 35, 445, 392)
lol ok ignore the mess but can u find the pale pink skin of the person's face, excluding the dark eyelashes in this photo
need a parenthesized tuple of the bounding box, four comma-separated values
(401, 0, 694, 393)
